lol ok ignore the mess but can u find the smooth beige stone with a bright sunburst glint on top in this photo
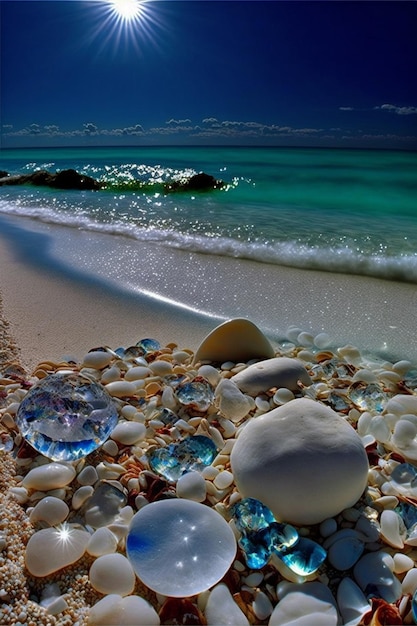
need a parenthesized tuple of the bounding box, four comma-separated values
(25, 525, 90, 577)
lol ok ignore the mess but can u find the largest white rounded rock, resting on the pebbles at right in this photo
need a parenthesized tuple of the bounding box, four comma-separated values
(230, 398, 369, 526)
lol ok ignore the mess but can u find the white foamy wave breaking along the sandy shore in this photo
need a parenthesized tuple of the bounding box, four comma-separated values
(0, 201, 417, 283)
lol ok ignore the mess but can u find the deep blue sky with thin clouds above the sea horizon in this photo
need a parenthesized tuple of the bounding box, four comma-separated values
(0, 0, 417, 149)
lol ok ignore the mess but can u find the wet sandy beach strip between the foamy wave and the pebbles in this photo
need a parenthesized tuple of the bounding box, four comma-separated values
(0, 216, 417, 368)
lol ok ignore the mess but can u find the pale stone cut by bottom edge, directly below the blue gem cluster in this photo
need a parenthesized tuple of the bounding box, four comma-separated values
(268, 582, 338, 626)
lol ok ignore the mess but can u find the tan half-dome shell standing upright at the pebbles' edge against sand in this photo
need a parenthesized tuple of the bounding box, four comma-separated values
(193, 318, 274, 363)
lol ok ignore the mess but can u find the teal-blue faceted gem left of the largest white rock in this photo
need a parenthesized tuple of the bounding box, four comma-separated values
(148, 435, 217, 482)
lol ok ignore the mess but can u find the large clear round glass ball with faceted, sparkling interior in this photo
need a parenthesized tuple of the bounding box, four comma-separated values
(16, 372, 118, 461)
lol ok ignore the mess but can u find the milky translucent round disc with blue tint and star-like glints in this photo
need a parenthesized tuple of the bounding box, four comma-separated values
(126, 498, 236, 598)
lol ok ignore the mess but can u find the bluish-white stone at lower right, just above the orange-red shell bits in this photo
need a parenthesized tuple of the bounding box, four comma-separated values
(353, 551, 402, 603)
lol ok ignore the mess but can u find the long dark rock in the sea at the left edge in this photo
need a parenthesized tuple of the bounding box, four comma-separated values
(0, 169, 102, 189)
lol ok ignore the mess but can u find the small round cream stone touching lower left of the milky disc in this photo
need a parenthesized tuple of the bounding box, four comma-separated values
(88, 552, 135, 596)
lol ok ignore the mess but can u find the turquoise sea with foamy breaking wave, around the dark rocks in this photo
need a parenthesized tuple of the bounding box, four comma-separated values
(0, 147, 417, 283)
